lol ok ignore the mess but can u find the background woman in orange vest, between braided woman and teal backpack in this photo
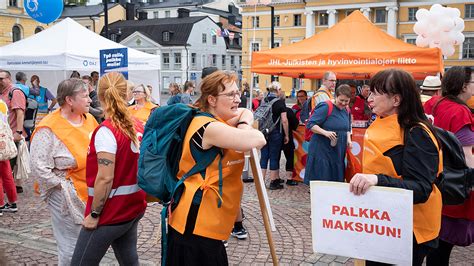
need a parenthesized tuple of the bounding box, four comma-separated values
(128, 84, 158, 125)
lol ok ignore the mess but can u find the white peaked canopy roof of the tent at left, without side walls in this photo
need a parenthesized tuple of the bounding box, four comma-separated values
(0, 18, 160, 71)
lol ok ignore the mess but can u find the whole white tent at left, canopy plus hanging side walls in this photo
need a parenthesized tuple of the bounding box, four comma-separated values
(0, 18, 160, 100)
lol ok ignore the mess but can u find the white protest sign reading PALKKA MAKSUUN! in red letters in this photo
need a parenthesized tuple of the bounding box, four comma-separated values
(311, 181, 413, 265)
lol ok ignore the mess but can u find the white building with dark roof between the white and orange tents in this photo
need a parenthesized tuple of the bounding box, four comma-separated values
(110, 10, 242, 93)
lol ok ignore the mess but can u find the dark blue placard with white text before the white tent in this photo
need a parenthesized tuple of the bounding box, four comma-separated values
(99, 48, 128, 79)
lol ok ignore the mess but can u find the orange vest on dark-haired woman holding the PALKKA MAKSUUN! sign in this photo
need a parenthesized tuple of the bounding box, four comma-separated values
(362, 114, 443, 244)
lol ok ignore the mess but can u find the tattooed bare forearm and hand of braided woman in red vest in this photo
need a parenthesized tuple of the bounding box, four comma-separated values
(82, 152, 115, 230)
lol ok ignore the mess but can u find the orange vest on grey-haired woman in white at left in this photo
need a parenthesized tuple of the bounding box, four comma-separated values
(31, 109, 98, 202)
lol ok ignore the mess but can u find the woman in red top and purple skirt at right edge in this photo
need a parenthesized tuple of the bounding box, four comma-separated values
(427, 66, 474, 266)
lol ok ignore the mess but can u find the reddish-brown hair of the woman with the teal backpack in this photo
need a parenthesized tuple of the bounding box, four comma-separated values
(196, 70, 237, 111)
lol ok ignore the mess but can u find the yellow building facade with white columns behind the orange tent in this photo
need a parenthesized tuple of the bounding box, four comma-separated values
(241, 0, 474, 93)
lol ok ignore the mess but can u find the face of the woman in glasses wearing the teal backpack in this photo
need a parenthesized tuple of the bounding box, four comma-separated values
(212, 79, 241, 121)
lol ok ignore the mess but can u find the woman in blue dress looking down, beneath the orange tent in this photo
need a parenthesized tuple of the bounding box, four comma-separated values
(304, 84, 352, 184)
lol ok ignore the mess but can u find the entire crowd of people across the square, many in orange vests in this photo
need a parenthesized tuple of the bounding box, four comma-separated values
(0, 67, 474, 265)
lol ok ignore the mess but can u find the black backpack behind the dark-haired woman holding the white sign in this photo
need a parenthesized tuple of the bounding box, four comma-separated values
(435, 127, 474, 205)
